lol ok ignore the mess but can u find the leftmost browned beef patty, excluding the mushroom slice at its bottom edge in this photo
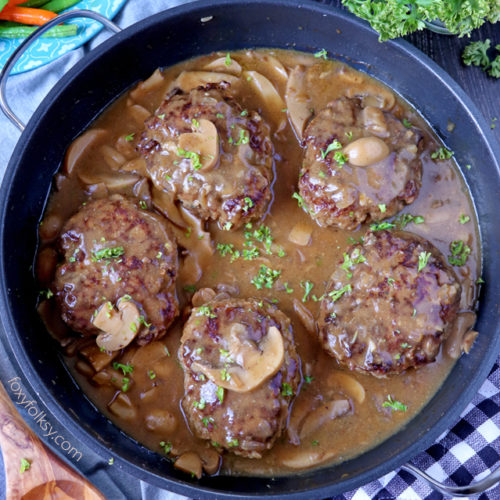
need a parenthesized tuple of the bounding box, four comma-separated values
(53, 195, 178, 344)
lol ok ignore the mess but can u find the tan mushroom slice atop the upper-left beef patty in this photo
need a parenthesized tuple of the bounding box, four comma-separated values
(179, 118, 219, 171)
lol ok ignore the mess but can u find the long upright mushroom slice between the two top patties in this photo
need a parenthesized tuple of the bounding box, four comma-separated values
(285, 65, 312, 139)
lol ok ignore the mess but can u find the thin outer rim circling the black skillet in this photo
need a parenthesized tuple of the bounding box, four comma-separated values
(0, 0, 500, 498)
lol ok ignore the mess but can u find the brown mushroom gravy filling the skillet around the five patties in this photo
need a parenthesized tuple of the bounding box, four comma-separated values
(38, 50, 480, 476)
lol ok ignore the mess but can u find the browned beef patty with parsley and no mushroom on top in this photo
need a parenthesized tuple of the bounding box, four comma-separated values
(318, 231, 461, 376)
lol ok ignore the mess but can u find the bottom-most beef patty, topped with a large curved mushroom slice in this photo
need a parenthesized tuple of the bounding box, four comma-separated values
(179, 299, 300, 458)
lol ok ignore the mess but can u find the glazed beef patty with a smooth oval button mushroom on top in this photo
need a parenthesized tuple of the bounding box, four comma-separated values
(299, 98, 422, 229)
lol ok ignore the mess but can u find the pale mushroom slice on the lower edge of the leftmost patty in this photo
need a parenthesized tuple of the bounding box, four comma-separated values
(92, 297, 140, 352)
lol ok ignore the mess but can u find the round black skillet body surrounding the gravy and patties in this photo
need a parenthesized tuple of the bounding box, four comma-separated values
(0, 0, 500, 498)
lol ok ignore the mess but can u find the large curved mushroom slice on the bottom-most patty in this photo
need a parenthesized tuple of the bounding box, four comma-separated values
(192, 323, 285, 392)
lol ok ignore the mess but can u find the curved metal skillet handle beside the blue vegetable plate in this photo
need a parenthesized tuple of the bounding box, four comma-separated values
(0, 10, 121, 132)
